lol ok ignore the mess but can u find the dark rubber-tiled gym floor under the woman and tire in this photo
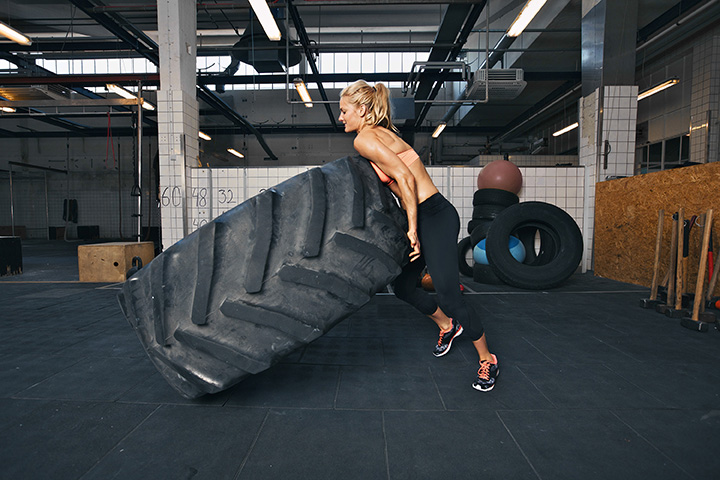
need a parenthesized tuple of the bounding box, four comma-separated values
(0, 241, 720, 480)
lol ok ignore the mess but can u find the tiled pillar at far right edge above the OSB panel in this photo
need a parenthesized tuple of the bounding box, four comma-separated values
(690, 35, 720, 163)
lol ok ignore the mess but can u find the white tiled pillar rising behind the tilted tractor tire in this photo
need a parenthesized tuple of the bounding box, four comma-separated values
(157, 0, 199, 248)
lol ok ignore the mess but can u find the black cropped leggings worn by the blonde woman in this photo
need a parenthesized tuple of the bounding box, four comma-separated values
(393, 193, 483, 341)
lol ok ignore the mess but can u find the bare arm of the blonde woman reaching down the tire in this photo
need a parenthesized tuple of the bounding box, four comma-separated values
(353, 132, 420, 262)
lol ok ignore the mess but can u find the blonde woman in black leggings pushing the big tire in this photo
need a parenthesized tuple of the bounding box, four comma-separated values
(339, 80, 499, 391)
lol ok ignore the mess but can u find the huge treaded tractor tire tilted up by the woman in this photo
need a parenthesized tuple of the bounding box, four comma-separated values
(119, 157, 410, 398)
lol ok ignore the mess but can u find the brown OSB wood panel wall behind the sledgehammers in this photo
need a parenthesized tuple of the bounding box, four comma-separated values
(594, 162, 720, 295)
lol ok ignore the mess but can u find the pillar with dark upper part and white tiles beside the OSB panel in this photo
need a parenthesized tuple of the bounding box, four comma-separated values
(578, 0, 638, 269)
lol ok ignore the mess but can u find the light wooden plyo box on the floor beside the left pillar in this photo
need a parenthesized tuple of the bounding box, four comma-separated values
(78, 242, 155, 283)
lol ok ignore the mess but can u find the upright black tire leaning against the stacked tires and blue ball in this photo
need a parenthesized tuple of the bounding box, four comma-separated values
(485, 202, 583, 290)
